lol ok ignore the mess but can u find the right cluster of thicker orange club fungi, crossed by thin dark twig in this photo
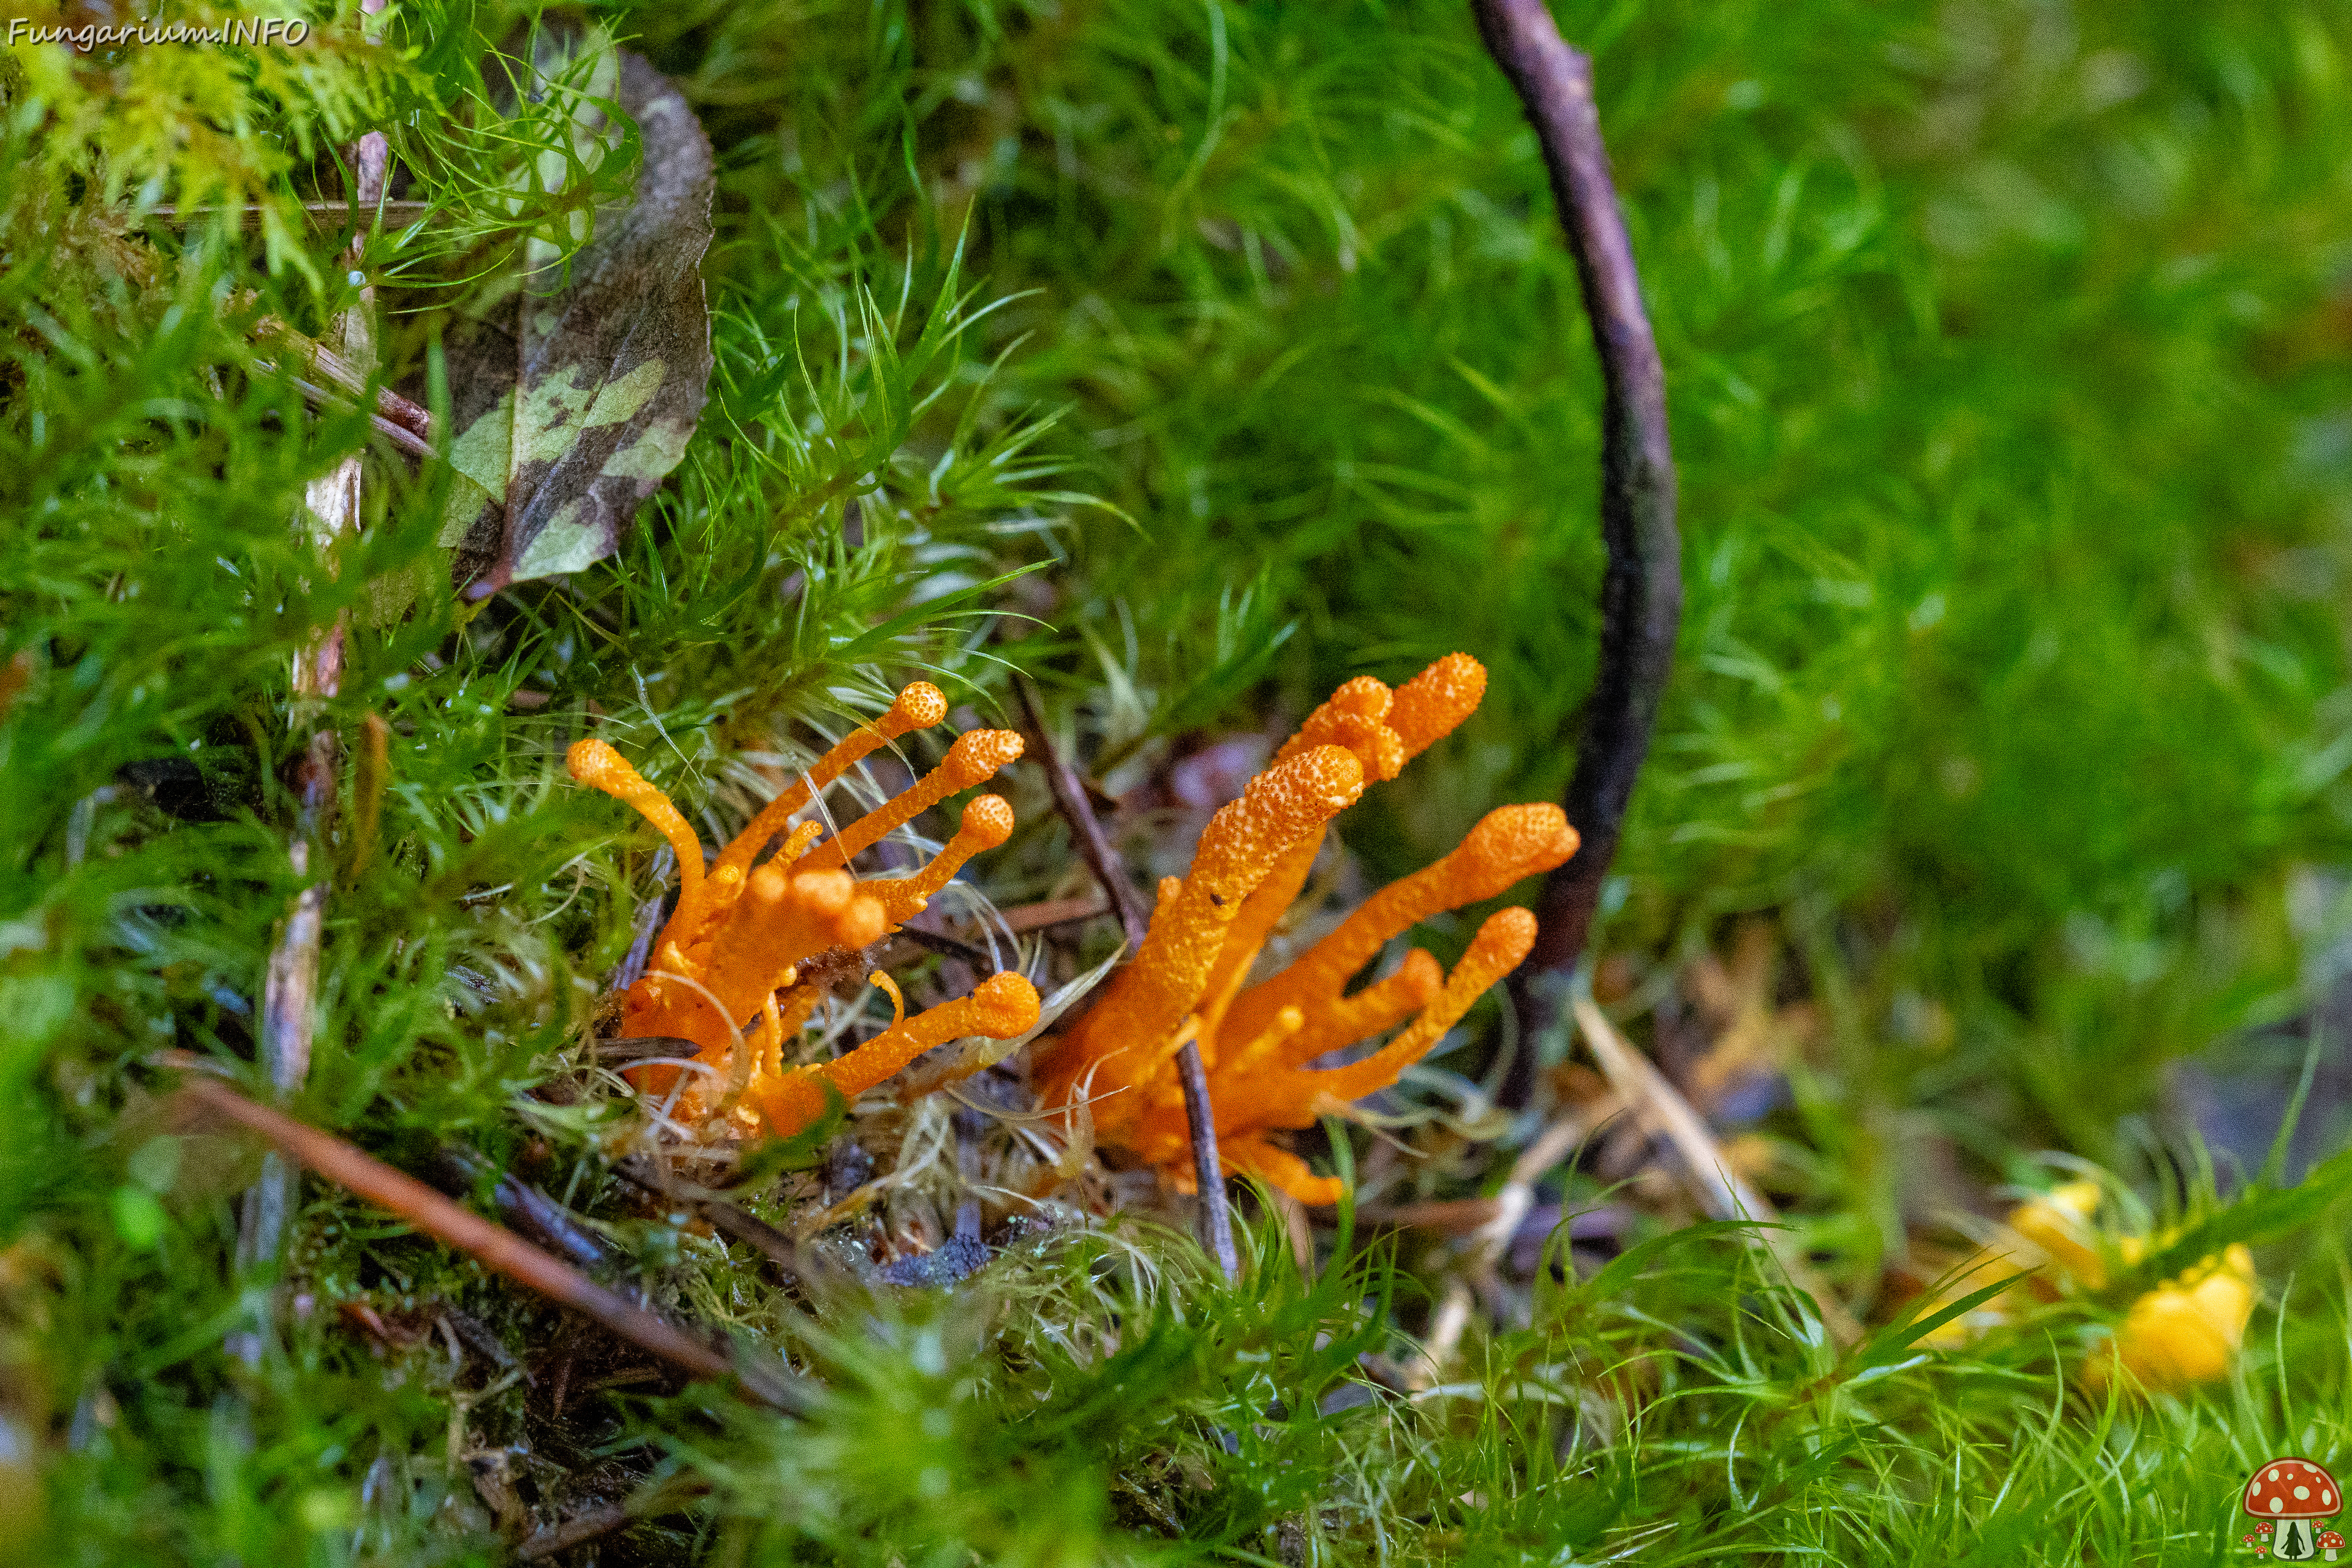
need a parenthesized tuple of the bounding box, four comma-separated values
(1035, 654, 1576, 1204)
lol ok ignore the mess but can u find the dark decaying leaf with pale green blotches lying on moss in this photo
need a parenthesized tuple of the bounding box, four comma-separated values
(440, 54, 713, 597)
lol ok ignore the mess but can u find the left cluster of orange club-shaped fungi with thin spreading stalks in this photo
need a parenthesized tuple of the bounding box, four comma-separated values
(567, 682, 1037, 1136)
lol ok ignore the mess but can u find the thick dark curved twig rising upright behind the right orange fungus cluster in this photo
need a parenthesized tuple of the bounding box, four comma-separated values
(1470, 0, 1682, 1091)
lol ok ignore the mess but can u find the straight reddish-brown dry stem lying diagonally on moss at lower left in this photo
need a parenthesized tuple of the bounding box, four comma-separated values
(181, 1072, 776, 1387)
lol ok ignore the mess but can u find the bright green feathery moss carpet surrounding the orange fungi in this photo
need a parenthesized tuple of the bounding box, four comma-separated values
(13, 0, 2352, 1563)
